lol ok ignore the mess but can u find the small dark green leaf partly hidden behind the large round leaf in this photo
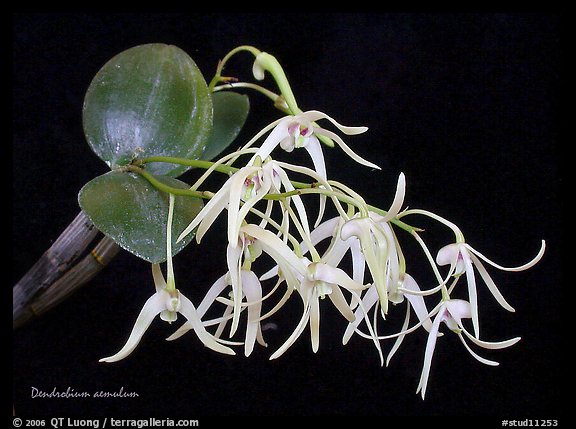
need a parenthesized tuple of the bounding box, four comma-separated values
(202, 92, 250, 161)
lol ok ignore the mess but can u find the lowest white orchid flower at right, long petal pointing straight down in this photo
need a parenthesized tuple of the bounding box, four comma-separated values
(416, 299, 520, 399)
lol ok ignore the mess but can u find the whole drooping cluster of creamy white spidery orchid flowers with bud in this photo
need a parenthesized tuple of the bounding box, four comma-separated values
(101, 46, 545, 398)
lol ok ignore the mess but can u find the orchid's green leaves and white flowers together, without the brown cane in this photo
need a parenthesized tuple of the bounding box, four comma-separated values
(12, 44, 545, 398)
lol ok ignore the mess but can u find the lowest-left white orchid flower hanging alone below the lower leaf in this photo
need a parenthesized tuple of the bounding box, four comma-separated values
(100, 264, 235, 362)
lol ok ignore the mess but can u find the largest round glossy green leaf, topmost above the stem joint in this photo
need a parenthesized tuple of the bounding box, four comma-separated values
(83, 43, 212, 177)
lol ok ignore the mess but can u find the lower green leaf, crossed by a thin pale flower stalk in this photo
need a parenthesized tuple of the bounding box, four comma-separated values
(78, 171, 203, 263)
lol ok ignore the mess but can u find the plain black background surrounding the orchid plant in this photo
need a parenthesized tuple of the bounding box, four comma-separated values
(7, 12, 568, 419)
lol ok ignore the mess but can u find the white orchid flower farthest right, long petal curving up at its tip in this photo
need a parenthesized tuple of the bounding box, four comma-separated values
(436, 240, 546, 338)
